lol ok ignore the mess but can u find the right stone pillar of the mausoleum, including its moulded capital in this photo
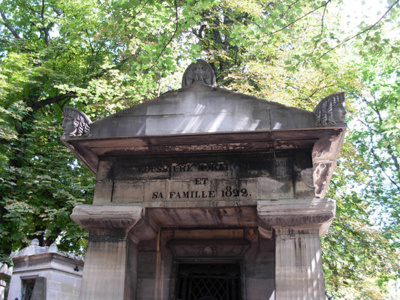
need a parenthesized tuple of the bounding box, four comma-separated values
(257, 199, 336, 300)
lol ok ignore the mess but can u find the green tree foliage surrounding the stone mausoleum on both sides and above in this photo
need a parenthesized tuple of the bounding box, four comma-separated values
(0, 0, 400, 299)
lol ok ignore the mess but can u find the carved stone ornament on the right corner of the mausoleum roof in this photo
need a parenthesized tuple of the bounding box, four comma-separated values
(314, 92, 347, 127)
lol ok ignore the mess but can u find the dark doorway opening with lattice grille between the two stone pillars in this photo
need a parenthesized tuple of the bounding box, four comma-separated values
(175, 264, 240, 300)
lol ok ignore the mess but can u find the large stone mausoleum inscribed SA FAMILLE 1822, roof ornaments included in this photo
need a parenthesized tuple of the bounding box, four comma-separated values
(62, 60, 346, 300)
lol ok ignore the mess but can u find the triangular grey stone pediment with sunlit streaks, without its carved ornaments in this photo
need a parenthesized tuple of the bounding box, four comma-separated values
(88, 83, 314, 138)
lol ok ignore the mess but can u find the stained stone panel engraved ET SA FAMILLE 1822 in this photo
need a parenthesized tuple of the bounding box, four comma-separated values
(110, 154, 306, 207)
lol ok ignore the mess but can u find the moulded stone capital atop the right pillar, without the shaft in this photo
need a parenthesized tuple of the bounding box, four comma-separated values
(257, 199, 336, 238)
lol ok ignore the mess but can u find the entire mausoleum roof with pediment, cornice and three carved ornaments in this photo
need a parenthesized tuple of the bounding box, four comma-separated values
(61, 60, 346, 173)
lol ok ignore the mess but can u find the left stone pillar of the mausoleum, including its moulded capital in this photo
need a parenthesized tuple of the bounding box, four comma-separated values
(71, 205, 142, 300)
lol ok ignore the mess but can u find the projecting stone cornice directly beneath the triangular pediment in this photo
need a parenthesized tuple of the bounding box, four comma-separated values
(63, 127, 345, 174)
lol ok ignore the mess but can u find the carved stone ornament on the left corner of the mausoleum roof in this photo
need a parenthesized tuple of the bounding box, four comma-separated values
(61, 107, 92, 139)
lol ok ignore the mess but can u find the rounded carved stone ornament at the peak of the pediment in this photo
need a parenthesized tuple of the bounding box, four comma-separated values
(182, 59, 216, 88)
